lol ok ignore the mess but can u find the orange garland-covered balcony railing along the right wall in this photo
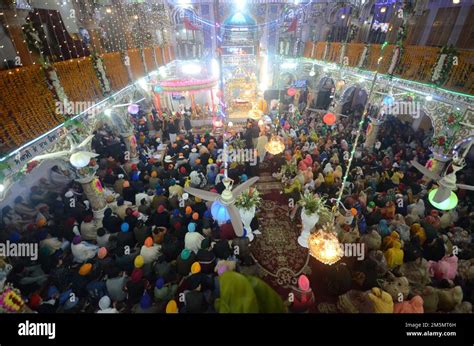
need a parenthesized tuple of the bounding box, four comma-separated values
(304, 42, 474, 94)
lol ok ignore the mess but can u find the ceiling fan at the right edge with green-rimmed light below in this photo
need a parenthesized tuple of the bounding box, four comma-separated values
(411, 146, 474, 203)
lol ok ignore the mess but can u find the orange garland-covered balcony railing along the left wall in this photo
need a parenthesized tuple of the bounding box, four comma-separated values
(0, 47, 174, 157)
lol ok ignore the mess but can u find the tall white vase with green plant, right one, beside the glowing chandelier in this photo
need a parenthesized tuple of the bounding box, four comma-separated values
(298, 192, 327, 248)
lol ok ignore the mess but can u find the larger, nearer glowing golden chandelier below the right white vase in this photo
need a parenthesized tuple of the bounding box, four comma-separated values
(308, 228, 344, 265)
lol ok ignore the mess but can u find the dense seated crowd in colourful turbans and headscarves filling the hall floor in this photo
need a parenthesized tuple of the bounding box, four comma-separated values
(0, 97, 474, 313)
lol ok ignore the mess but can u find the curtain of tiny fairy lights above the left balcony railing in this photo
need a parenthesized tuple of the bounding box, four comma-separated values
(0, 0, 171, 69)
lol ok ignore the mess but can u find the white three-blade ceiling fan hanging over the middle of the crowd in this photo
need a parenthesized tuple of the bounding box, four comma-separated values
(184, 177, 259, 237)
